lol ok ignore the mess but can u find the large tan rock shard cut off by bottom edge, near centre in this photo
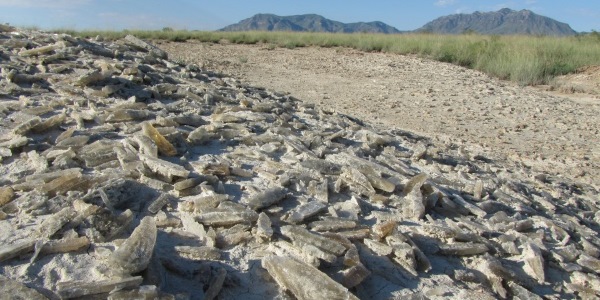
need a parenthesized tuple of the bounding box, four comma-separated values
(262, 256, 358, 300)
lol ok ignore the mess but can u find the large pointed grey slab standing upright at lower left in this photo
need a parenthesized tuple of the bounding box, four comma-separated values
(108, 216, 157, 274)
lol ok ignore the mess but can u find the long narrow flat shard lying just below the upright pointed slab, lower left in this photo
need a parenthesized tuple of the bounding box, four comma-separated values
(56, 276, 143, 299)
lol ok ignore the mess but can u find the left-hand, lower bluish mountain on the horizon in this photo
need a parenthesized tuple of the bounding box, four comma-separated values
(220, 14, 400, 33)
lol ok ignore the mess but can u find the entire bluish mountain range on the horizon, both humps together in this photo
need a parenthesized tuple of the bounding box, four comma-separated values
(220, 8, 577, 36)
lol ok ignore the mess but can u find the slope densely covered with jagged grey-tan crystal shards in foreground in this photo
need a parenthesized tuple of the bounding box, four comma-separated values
(0, 26, 600, 299)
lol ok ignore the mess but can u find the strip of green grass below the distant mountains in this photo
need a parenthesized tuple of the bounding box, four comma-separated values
(60, 29, 600, 85)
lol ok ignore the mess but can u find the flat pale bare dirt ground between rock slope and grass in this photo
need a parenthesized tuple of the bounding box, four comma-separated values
(160, 42, 600, 186)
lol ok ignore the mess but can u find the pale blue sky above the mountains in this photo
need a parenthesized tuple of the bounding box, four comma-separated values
(0, 0, 600, 31)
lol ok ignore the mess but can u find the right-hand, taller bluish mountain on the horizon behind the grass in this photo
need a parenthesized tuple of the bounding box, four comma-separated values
(416, 8, 577, 36)
